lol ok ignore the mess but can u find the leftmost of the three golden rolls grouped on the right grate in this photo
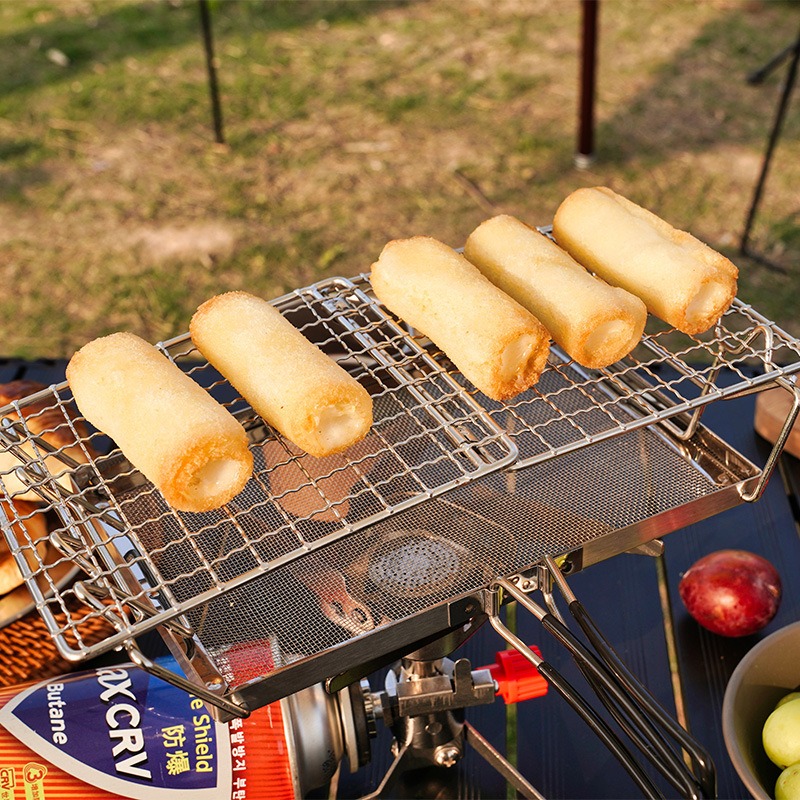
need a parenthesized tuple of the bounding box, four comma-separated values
(370, 236, 550, 400)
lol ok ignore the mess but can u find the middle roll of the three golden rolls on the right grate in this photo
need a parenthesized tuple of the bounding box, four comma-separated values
(464, 215, 647, 369)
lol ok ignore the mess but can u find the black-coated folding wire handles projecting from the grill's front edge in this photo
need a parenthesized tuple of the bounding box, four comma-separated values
(489, 556, 717, 800)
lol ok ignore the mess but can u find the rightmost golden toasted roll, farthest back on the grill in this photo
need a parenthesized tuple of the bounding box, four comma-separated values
(553, 186, 739, 334)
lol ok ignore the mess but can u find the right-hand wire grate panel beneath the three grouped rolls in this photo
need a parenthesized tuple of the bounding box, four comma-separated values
(456, 300, 800, 469)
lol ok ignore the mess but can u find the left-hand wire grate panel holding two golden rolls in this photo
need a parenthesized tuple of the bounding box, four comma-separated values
(0, 279, 516, 657)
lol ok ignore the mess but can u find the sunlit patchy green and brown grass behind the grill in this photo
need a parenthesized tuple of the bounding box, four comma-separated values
(0, 0, 800, 356)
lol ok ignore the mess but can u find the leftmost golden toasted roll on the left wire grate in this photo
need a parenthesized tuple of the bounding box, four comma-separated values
(67, 333, 253, 511)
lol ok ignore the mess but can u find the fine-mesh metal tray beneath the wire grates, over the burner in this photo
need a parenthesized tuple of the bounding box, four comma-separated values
(190, 400, 758, 697)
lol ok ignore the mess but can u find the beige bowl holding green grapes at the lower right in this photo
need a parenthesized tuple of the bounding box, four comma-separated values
(722, 622, 800, 800)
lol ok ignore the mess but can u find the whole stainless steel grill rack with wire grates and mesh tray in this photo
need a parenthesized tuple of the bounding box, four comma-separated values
(0, 276, 800, 714)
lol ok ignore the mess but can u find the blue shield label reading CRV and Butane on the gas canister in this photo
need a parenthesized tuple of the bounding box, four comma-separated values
(0, 665, 232, 800)
